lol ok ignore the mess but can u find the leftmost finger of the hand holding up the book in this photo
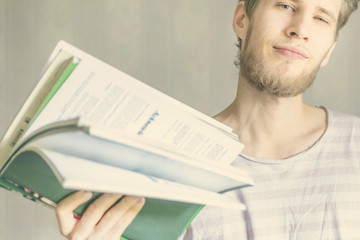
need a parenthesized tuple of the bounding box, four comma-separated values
(55, 191, 92, 236)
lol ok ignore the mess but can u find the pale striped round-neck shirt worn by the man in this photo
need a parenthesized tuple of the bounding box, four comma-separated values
(184, 110, 360, 240)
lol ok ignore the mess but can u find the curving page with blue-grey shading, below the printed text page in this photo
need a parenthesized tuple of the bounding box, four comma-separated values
(22, 130, 253, 192)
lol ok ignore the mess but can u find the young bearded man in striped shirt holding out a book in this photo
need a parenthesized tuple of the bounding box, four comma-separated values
(57, 0, 360, 240)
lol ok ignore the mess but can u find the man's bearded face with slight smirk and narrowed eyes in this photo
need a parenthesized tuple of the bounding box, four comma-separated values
(240, 0, 341, 97)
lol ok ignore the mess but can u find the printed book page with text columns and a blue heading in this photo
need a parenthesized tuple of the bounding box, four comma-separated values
(29, 45, 243, 164)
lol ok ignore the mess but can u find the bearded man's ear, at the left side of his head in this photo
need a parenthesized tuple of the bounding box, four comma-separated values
(233, 1, 249, 41)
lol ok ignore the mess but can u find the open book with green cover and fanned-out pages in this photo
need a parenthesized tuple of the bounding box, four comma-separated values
(0, 41, 253, 239)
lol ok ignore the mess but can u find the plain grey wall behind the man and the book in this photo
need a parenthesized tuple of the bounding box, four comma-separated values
(0, 0, 360, 240)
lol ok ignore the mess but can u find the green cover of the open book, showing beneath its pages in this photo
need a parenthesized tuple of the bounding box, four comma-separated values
(1, 151, 203, 240)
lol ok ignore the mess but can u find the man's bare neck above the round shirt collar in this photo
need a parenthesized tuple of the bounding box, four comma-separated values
(215, 79, 327, 159)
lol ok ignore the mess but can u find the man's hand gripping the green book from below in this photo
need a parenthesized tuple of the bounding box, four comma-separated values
(56, 191, 145, 240)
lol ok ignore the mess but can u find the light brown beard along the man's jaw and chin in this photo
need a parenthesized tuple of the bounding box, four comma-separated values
(240, 28, 320, 97)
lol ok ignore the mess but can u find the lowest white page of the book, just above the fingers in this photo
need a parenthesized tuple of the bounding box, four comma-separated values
(42, 150, 245, 210)
